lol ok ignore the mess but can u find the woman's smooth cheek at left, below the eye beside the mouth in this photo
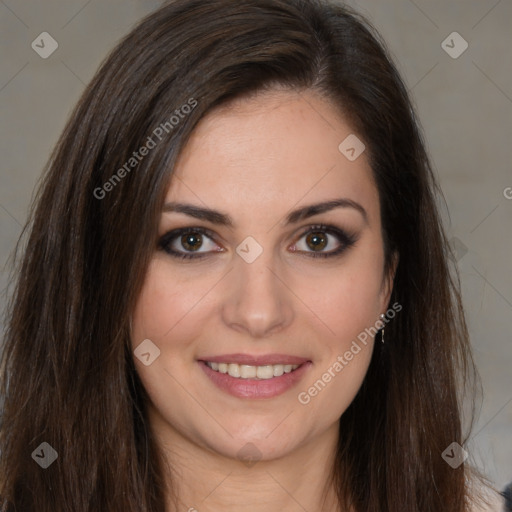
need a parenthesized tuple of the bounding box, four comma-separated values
(131, 256, 212, 428)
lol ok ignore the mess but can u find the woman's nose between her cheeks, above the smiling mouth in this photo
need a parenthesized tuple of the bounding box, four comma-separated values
(222, 251, 295, 338)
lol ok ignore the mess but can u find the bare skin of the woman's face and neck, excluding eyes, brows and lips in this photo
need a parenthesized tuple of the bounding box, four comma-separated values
(132, 89, 394, 512)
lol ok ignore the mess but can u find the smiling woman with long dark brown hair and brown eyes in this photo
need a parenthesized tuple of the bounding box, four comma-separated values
(0, 0, 506, 512)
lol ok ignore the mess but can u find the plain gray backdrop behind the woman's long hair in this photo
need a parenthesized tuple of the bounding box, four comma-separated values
(0, 0, 512, 488)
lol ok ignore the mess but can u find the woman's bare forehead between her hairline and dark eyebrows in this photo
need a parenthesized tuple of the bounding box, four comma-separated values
(166, 90, 378, 226)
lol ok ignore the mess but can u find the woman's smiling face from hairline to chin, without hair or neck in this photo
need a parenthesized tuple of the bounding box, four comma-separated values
(132, 90, 391, 460)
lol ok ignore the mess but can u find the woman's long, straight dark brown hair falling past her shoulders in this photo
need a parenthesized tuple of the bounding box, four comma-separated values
(0, 0, 482, 512)
